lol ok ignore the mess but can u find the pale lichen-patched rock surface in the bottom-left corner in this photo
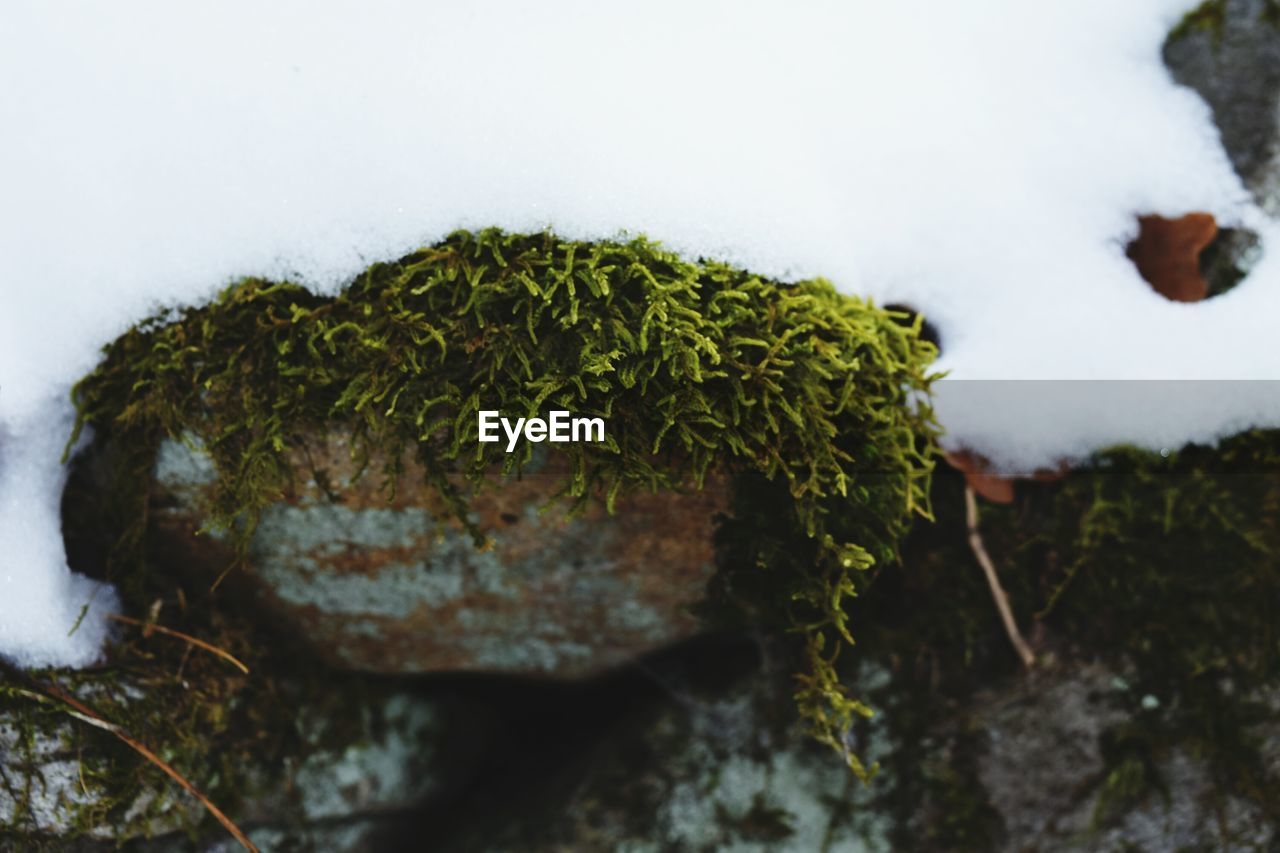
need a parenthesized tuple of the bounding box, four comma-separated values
(0, 674, 485, 852)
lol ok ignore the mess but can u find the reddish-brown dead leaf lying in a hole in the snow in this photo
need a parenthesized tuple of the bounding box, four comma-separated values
(1131, 213, 1217, 302)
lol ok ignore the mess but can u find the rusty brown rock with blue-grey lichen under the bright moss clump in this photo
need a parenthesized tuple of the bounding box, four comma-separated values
(152, 430, 726, 678)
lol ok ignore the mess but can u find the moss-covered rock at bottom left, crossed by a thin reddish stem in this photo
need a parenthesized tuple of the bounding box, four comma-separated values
(0, 653, 485, 849)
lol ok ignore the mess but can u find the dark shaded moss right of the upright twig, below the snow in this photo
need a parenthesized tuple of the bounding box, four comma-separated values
(1023, 432, 1280, 818)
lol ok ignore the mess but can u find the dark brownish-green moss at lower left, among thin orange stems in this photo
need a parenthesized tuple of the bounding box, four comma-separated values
(0, 568, 371, 849)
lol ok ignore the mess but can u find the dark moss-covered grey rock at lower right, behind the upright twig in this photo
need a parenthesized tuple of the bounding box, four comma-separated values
(852, 432, 1280, 849)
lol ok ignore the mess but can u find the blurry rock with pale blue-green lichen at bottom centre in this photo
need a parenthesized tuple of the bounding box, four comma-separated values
(444, 640, 892, 853)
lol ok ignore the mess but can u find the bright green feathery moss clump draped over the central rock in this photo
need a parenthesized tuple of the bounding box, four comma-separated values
(74, 225, 936, 774)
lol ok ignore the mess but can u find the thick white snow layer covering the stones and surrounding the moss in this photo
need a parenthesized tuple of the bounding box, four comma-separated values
(0, 0, 1280, 665)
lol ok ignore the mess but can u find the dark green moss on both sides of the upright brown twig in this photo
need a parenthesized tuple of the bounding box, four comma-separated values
(851, 432, 1280, 849)
